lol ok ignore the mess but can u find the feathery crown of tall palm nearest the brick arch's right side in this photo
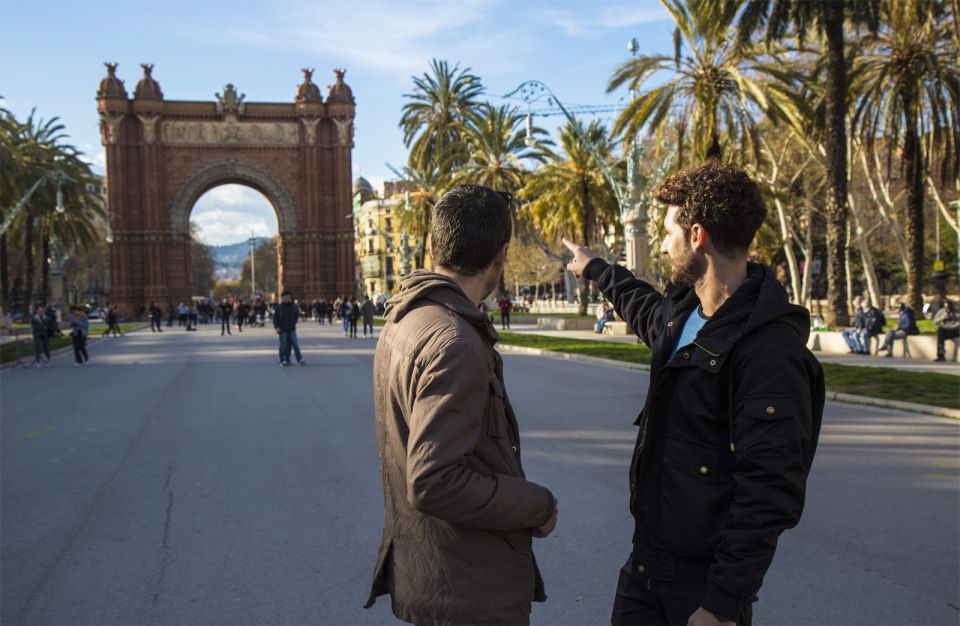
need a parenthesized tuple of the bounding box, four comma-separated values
(400, 59, 483, 171)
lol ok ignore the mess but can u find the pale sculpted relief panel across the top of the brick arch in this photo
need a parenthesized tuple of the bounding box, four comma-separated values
(161, 119, 300, 146)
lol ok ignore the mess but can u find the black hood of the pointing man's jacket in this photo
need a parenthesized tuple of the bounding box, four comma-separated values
(667, 263, 810, 354)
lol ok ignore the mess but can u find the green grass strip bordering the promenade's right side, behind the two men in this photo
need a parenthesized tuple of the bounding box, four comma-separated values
(500, 333, 960, 409)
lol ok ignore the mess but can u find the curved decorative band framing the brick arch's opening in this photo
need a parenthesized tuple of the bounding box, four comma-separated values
(170, 159, 297, 235)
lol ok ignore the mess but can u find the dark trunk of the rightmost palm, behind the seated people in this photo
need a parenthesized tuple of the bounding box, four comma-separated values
(903, 97, 923, 314)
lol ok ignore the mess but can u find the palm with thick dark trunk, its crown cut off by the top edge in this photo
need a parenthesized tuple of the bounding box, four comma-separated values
(725, 0, 879, 326)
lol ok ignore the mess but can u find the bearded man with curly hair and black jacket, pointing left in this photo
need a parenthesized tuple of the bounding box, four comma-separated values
(564, 160, 824, 626)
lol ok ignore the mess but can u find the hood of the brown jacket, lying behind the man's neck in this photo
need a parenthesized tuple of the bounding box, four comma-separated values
(384, 270, 500, 342)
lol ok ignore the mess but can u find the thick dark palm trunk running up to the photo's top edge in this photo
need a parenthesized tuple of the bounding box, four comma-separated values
(823, 2, 850, 328)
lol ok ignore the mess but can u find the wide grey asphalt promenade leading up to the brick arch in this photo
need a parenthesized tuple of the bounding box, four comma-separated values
(0, 325, 960, 626)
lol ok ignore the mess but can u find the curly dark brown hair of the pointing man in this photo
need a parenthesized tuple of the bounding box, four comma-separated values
(656, 159, 767, 258)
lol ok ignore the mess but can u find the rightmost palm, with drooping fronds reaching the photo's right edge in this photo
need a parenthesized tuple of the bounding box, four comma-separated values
(853, 0, 960, 311)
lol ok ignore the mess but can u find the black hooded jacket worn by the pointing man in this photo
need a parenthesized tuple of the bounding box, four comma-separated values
(584, 259, 824, 620)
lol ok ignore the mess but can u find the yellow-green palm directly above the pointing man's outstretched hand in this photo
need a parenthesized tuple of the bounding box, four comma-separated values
(521, 119, 623, 315)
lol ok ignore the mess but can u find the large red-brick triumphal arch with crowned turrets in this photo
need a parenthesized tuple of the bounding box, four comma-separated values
(97, 63, 356, 312)
